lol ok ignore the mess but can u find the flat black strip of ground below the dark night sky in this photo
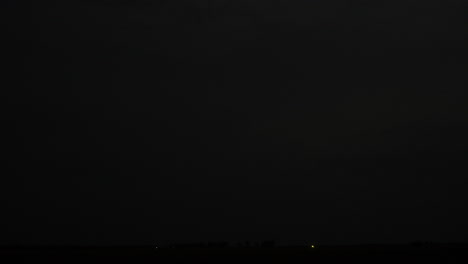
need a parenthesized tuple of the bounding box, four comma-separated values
(0, 245, 468, 264)
